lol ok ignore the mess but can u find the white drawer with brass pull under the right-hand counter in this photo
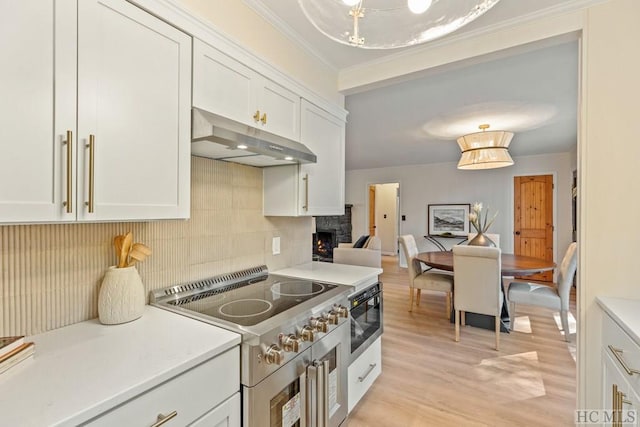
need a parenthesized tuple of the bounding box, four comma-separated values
(602, 314, 640, 390)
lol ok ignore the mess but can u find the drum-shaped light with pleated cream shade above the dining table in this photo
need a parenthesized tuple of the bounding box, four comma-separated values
(458, 124, 513, 170)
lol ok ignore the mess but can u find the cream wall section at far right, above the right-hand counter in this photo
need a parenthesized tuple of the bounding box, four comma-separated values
(578, 0, 640, 408)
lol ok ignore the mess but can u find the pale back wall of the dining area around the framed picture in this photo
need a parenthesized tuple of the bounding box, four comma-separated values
(346, 153, 574, 260)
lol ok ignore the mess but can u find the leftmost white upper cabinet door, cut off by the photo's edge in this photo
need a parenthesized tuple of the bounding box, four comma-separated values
(0, 0, 76, 222)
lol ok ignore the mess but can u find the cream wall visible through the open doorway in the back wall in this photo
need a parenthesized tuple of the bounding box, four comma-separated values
(372, 183, 398, 255)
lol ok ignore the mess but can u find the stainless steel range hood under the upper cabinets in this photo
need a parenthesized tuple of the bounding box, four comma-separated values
(191, 108, 316, 167)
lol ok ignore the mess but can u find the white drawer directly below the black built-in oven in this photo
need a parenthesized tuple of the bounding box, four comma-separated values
(348, 338, 382, 412)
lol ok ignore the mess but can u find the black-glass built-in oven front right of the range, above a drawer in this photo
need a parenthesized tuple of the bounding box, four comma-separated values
(349, 282, 382, 364)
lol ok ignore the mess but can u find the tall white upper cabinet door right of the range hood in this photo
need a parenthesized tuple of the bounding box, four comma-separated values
(299, 100, 345, 215)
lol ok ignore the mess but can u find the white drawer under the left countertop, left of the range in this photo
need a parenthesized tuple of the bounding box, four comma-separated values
(86, 346, 240, 427)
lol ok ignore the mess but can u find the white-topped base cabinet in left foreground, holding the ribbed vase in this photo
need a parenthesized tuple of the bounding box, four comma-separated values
(0, 306, 240, 427)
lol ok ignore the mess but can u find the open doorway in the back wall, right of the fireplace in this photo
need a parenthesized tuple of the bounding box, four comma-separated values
(367, 182, 400, 255)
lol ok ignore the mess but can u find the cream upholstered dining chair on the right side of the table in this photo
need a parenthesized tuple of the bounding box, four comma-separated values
(507, 242, 578, 341)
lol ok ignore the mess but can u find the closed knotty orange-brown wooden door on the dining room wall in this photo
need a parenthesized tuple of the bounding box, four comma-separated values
(513, 175, 553, 282)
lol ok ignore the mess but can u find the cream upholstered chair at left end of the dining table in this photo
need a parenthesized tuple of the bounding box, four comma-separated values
(398, 234, 453, 319)
